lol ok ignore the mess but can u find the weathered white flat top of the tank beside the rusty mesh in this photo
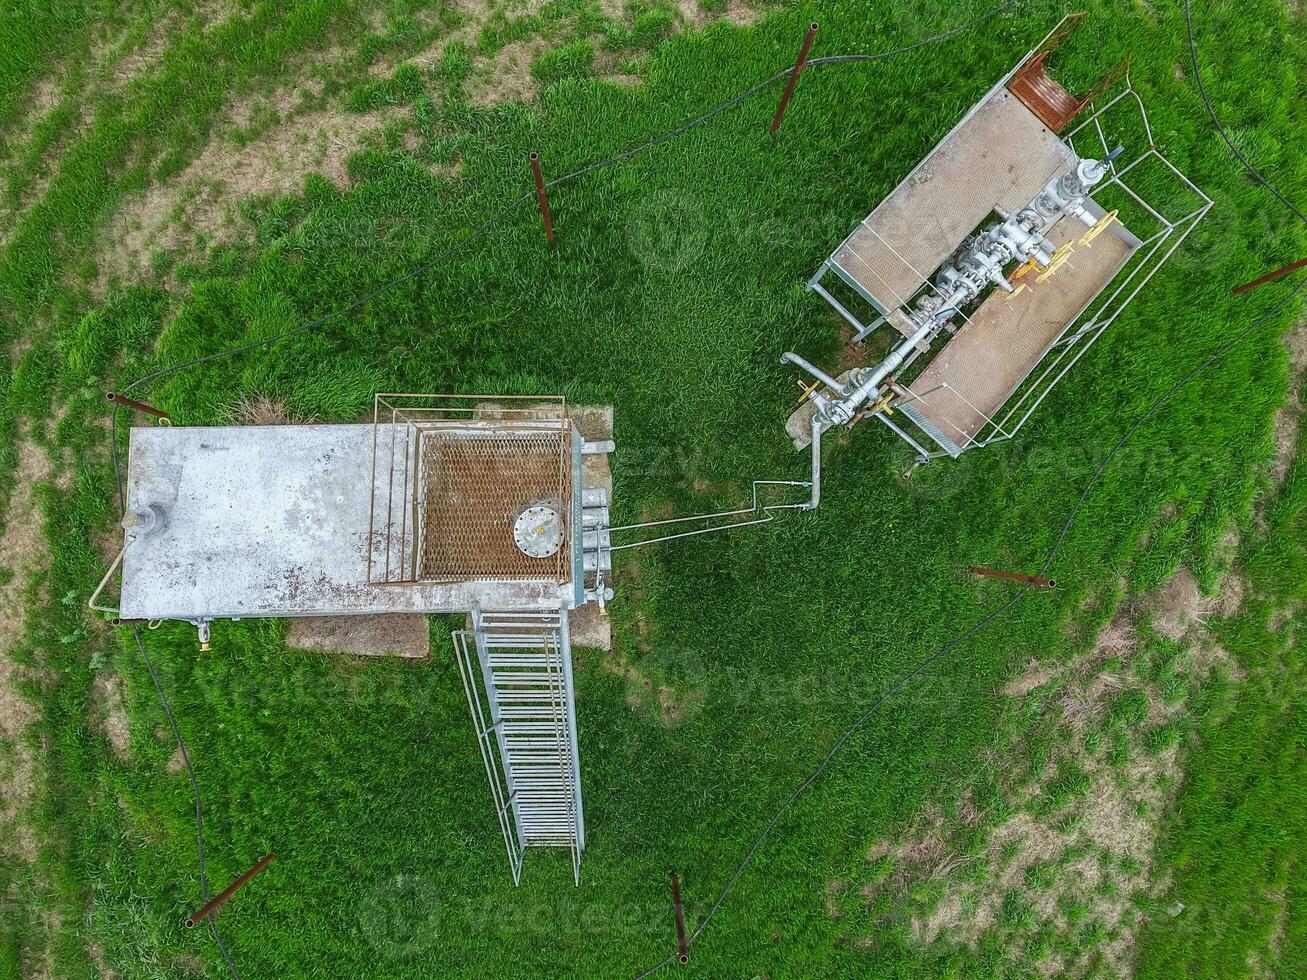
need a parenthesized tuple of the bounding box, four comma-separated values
(120, 425, 572, 619)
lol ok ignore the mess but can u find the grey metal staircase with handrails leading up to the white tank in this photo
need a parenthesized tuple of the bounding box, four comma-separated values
(454, 610, 586, 885)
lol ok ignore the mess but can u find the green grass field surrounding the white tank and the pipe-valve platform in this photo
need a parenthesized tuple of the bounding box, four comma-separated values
(0, 0, 1307, 980)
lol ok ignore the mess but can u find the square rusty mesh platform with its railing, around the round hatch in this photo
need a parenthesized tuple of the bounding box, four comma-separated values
(369, 395, 575, 585)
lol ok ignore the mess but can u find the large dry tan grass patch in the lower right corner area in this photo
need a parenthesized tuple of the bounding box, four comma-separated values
(846, 568, 1238, 976)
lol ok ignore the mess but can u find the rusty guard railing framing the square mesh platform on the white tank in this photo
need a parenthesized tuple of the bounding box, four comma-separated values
(367, 393, 578, 585)
